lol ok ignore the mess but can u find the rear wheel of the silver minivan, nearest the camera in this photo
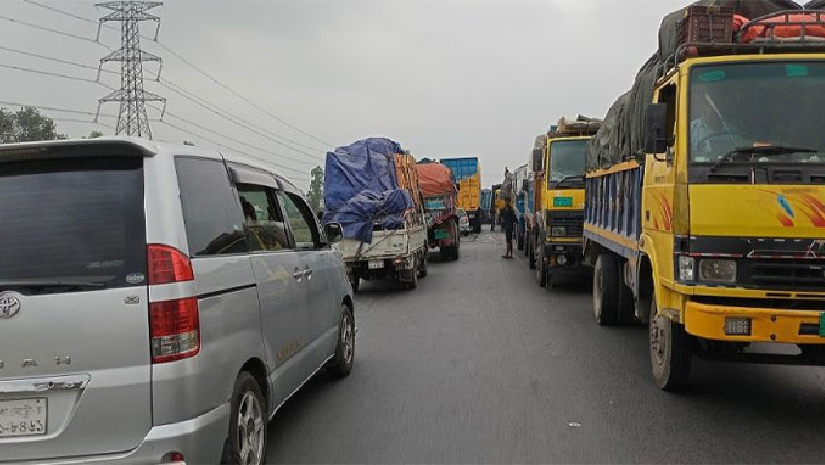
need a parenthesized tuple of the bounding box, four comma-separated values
(224, 371, 267, 465)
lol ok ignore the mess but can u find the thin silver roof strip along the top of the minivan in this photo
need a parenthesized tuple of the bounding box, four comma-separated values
(0, 136, 300, 192)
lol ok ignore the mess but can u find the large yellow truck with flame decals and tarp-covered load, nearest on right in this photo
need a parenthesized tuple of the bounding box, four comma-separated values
(584, 2, 825, 390)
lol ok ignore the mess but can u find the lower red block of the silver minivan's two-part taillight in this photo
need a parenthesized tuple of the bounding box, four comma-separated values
(149, 297, 201, 363)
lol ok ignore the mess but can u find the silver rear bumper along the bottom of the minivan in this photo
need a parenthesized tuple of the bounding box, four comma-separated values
(12, 403, 230, 465)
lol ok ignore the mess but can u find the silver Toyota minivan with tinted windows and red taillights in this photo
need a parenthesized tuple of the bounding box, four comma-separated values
(0, 138, 355, 464)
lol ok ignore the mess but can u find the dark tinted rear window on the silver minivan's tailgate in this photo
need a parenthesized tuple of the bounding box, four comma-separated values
(0, 157, 146, 292)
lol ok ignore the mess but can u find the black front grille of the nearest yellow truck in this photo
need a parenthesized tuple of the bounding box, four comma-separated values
(747, 259, 825, 291)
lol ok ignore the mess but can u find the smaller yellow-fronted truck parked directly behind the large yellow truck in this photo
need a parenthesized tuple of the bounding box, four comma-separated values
(522, 116, 601, 289)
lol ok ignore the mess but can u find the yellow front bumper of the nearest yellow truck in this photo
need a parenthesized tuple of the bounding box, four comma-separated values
(685, 302, 825, 344)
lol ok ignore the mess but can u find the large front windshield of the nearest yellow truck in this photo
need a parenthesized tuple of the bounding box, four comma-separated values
(688, 62, 825, 163)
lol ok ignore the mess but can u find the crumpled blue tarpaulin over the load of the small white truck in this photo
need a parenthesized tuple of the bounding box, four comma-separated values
(323, 139, 414, 243)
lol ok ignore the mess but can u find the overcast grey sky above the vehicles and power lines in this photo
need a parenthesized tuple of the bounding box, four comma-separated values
(0, 0, 688, 186)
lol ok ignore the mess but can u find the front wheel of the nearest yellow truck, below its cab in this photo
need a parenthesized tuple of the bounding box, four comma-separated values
(648, 295, 693, 392)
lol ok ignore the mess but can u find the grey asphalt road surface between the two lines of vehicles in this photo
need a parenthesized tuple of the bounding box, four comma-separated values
(268, 232, 825, 463)
